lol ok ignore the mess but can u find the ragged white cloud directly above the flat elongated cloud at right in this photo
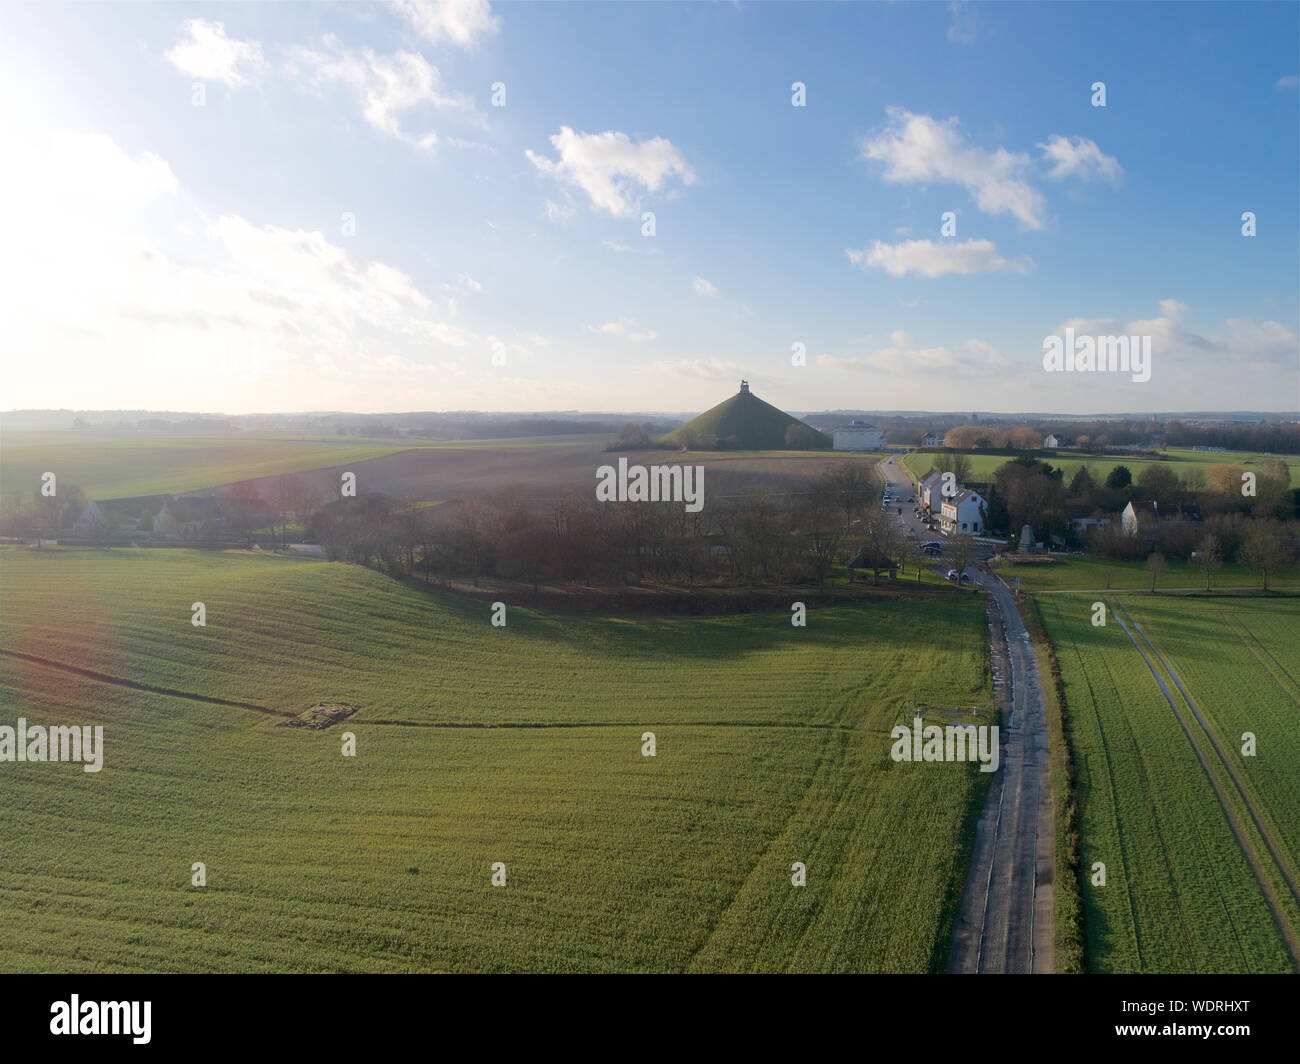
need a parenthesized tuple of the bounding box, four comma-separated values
(858, 107, 1044, 229)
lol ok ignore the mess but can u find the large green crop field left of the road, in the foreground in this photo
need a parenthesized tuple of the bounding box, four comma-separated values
(0, 549, 992, 972)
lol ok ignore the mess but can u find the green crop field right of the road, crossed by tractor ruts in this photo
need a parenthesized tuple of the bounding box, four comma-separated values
(1036, 594, 1300, 973)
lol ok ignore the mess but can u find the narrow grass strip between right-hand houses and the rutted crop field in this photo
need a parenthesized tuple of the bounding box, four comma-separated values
(995, 554, 1300, 592)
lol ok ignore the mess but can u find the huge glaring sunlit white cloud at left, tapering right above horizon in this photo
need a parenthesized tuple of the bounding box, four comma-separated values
(0, 130, 476, 411)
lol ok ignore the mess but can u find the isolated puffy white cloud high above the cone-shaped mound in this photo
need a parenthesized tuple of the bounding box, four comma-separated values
(524, 126, 696, 217)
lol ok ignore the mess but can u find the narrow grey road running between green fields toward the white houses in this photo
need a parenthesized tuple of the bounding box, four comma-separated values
(878, 458, 1056, 973)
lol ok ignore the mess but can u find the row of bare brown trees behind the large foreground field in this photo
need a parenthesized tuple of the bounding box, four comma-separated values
(307, 463, 920, 591)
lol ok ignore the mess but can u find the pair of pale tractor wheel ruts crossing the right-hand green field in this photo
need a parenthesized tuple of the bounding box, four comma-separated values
(1112, 605, 1300, 968)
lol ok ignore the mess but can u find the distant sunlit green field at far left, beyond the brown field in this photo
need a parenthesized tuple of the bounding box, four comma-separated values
(0, 431, 608, 498)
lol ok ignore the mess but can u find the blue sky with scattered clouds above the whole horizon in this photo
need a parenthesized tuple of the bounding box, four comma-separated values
(0, 0, 1300, 412)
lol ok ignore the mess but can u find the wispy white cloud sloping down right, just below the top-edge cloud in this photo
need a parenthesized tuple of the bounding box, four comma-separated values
(287, 34, 472, 151)
